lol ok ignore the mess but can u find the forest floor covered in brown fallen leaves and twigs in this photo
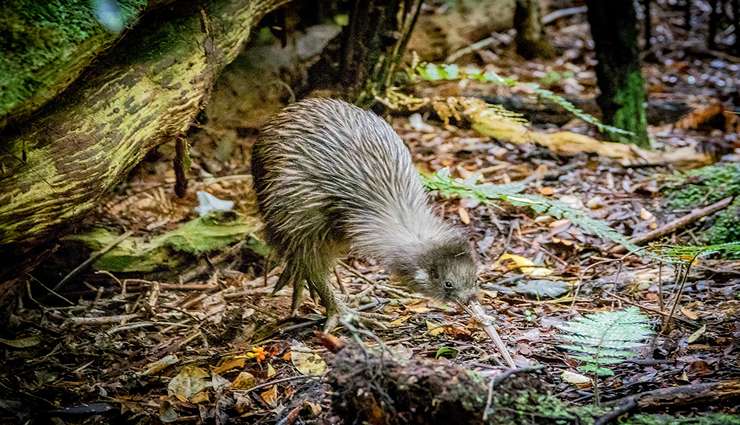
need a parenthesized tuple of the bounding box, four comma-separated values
(0, 1, 740, 424)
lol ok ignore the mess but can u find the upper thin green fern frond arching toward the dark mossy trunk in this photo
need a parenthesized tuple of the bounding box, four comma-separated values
(410, 63, 634, 136)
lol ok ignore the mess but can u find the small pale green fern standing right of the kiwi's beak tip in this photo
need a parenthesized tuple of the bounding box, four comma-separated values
(559, 307, 652, 376)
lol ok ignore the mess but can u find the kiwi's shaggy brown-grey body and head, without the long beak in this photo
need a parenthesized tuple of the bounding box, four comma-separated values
(252, 99, 477, 322)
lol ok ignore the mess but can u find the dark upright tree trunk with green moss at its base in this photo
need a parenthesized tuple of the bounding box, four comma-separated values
(587, 0, 650, 147)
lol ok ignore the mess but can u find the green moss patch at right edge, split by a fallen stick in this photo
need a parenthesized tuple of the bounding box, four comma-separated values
(664, 164, 740, 244)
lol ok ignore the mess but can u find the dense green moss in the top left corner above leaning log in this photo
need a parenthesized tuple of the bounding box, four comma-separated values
(0, 0, 148, 123)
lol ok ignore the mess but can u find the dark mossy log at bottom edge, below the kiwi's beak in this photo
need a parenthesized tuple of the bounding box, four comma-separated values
(328, 345, 591, 425)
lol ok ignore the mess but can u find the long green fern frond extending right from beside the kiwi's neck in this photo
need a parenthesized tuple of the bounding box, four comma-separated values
(422, 168, 640, 253)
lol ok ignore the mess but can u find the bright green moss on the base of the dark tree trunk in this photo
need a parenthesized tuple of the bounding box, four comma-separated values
(610, 69, 650, 148)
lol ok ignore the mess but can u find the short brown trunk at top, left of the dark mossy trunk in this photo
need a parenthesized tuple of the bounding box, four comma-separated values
(514, 0, 555, 59)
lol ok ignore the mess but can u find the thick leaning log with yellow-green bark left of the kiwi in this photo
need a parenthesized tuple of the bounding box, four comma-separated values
(0, 0, 287, 248)
